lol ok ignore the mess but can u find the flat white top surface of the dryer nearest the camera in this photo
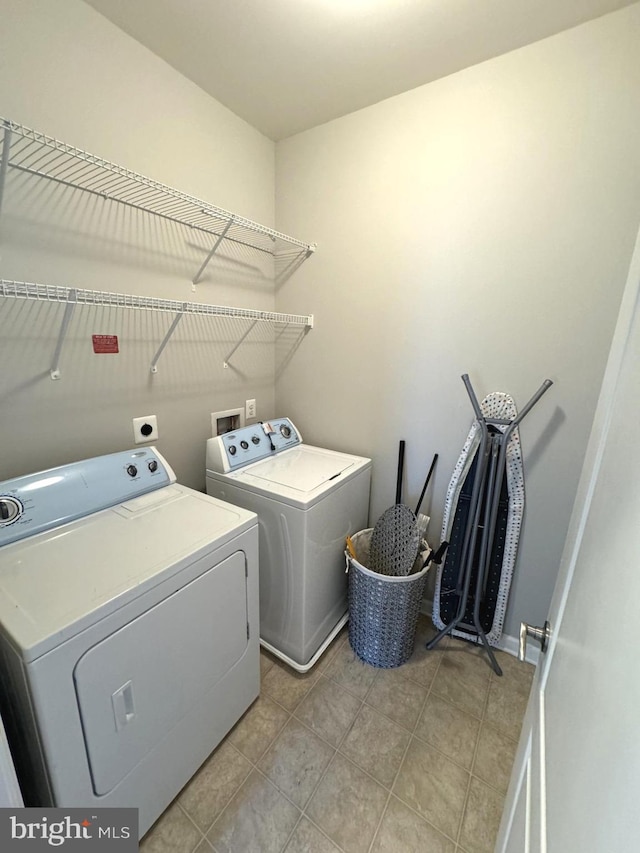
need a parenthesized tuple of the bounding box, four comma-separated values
(0, 485, 257, 661)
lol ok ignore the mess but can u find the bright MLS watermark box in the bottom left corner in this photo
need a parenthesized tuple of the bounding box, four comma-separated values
(0, 808, 138, 853)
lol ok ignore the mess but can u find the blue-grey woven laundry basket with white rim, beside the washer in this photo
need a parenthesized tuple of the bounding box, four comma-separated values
(346, 528, 429, 669)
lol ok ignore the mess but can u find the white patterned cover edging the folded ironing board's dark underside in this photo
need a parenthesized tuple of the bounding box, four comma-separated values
(433, 391, 524, 646)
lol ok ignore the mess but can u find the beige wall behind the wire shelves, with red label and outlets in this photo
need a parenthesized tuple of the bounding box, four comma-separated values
(0, 0, 274, 488)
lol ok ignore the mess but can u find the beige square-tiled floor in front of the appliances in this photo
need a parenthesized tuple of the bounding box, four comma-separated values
(140, 616, 533, 853)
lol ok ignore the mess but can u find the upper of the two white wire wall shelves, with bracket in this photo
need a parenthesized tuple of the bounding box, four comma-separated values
(0, 118, 316, 284)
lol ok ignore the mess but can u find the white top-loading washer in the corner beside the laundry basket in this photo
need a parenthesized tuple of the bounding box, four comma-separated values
(207, 418, 371, 672)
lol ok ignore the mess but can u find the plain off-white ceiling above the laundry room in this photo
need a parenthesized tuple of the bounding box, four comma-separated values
(85, 0, 635, 140)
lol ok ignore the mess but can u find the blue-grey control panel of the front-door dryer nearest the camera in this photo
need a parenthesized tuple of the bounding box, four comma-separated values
(0, 447, 176, 546)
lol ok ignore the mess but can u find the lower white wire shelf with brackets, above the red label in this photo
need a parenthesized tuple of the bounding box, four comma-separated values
(0, 279, 313, 379)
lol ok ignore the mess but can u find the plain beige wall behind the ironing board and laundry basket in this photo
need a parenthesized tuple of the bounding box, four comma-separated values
(276, 4, 640, 635)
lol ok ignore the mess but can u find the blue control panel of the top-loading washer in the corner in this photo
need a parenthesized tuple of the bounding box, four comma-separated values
(207, 418, 302, 474)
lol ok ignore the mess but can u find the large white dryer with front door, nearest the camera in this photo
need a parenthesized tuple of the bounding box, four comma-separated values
(0, 448, 260, 835)
